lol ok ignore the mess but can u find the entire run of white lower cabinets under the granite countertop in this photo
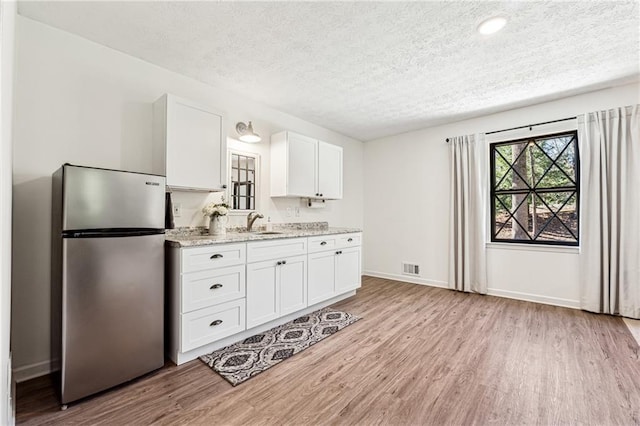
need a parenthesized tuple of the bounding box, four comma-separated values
(167, 233, 362, 364)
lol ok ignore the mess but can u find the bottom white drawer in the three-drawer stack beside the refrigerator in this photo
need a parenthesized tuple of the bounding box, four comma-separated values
(180, 299, 245, 352)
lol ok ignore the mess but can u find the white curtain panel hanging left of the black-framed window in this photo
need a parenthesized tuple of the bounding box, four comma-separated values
(449, 135, 488, 294)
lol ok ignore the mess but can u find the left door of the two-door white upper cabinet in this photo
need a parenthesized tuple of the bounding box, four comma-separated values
(287, 132, 318, 197)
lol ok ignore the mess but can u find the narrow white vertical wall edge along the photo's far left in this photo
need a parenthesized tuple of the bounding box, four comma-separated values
(0, 1, 16, 424)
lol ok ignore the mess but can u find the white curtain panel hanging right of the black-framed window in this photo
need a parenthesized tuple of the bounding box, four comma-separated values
(578, 105, 640, 319)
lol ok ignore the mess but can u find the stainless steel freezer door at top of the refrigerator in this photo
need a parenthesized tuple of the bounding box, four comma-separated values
(62, 165, 165, 230)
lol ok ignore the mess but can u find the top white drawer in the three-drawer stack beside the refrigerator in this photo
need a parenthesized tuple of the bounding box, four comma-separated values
(182, 243, 247, 273)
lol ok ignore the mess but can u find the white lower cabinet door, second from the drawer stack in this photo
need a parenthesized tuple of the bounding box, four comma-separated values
(279, 255, 307, 316)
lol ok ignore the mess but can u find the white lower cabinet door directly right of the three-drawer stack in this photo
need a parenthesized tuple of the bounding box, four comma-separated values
(247, 260, 280, 328)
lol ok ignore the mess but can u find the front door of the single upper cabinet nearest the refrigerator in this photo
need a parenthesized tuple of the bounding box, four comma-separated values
(165, 96, 226, 190)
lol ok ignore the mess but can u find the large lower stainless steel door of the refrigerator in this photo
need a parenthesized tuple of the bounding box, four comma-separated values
(61, 235, 164, 404)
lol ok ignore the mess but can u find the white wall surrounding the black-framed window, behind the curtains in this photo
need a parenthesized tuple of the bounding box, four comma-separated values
(364, 84, 640, 307)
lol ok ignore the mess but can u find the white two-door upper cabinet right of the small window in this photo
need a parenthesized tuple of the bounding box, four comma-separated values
(271, 132, 342, 200)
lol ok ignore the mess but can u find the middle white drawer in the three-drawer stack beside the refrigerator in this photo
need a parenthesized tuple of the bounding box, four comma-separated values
(182, 265, 246, 313)
